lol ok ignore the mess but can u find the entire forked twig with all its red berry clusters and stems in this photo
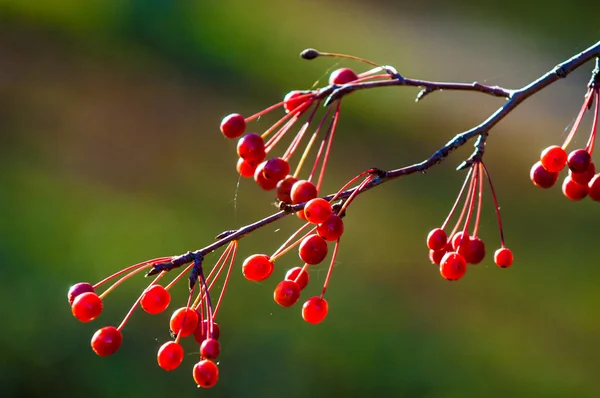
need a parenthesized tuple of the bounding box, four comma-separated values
(68, 42, 600, 388)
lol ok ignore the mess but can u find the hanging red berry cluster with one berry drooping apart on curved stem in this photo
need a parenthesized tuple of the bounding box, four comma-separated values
(427, 160, 513, 281)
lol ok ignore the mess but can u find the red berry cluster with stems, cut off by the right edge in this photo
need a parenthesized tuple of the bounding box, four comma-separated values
(530, 88, 600, 201)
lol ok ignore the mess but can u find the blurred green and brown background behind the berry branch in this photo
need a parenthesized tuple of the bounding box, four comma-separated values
(0, 0, 600, 397)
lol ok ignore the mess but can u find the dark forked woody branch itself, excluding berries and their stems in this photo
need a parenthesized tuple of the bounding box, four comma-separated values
(147, 41, 600, 276)
